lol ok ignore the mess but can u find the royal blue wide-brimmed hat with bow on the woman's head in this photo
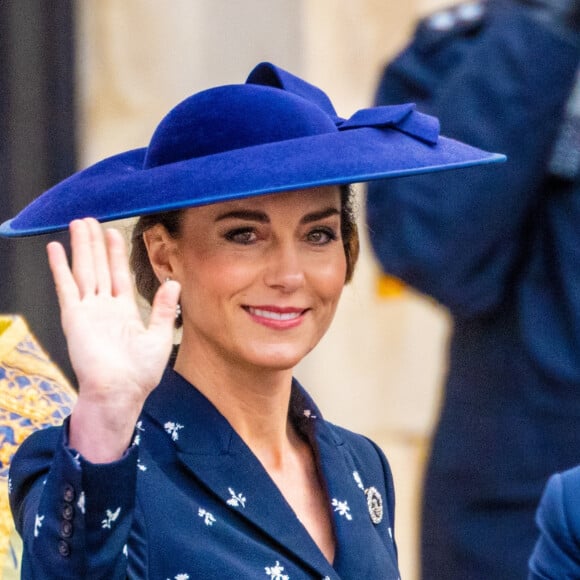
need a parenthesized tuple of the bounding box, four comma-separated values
(0, 63, 505, 237)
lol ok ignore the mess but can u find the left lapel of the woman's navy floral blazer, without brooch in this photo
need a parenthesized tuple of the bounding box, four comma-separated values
(144, 369, 336, 578)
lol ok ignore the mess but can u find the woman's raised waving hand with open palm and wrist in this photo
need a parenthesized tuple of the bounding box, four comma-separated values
(47, 218, 180, 463)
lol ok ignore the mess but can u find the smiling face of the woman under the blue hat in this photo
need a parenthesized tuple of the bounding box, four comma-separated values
(165, 187, 346, 369)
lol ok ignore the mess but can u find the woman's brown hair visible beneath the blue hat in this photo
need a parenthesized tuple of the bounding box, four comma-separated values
(130, 185, 360, 325)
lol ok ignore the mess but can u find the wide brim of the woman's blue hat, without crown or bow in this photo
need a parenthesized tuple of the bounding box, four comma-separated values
(0, 127, 505, 237)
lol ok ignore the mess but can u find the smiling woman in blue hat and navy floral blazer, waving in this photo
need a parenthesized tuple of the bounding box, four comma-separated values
(0, 64, 501, 580)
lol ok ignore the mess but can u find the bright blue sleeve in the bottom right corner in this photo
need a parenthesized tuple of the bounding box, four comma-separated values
(529, 468, 580, 580)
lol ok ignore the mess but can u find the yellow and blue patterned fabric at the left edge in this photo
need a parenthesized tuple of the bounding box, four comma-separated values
(0, 315, 76, 580)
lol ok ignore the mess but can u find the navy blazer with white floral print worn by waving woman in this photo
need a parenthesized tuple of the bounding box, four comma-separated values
(10, 368, 399, 580)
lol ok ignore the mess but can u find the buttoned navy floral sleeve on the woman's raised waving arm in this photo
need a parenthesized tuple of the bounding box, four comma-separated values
(10, 423, 138, 580)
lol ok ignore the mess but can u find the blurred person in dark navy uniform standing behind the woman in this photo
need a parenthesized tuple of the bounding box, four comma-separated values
(367, 0, 580, 580)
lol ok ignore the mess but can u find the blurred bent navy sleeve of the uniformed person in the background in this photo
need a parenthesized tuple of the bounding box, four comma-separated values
(367, 2, 579, 317)
